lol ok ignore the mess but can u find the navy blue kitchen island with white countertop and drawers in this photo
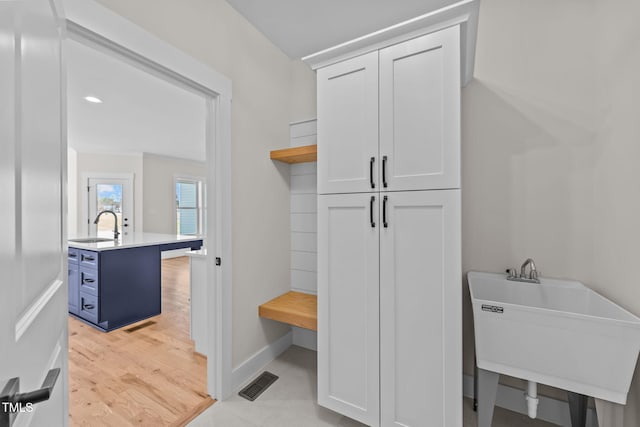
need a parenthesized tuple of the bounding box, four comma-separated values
(68, 233, 203, 331)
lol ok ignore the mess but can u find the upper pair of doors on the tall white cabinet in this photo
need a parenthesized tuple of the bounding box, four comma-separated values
(318, 27, 460, 194)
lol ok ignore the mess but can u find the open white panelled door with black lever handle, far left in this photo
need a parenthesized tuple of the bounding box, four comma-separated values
(0, 0, 68, 426)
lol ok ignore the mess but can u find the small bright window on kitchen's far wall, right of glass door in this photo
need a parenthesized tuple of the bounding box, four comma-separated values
(176, 178, 206, 235)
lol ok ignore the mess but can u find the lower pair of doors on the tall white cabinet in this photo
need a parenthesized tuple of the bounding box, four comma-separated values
(318, 190, 462, 427)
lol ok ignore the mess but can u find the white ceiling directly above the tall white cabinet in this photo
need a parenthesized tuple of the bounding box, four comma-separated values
(227, 0, 459, 59)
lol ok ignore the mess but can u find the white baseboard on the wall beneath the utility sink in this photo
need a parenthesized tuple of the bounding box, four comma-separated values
(463, 375, 598, 427)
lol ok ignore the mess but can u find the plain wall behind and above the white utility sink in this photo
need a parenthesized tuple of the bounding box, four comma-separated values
(462, 0, 640, 427)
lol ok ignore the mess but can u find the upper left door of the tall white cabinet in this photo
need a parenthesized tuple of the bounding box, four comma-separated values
(318, 52, 379, 194)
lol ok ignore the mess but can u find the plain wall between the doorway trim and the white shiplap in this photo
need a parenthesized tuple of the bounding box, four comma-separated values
(98, 0, 315, 367)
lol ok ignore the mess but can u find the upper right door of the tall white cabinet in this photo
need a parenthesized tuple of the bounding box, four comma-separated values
(380, 26, 460, 191)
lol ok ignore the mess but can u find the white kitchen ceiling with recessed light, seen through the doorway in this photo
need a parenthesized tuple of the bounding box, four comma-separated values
(65, 40, 206, 161)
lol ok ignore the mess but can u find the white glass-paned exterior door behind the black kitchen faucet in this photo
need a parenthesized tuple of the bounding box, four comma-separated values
(87, 175, 134, 236)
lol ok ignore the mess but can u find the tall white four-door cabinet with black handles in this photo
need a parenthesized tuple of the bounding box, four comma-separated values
(318, 26, 462, 427)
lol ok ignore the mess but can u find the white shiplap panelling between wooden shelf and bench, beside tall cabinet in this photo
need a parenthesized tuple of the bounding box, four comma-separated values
(289, 120, 318, 294)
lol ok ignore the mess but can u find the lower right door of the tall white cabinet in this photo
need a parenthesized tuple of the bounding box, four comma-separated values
(380, 190, 462, 427)
